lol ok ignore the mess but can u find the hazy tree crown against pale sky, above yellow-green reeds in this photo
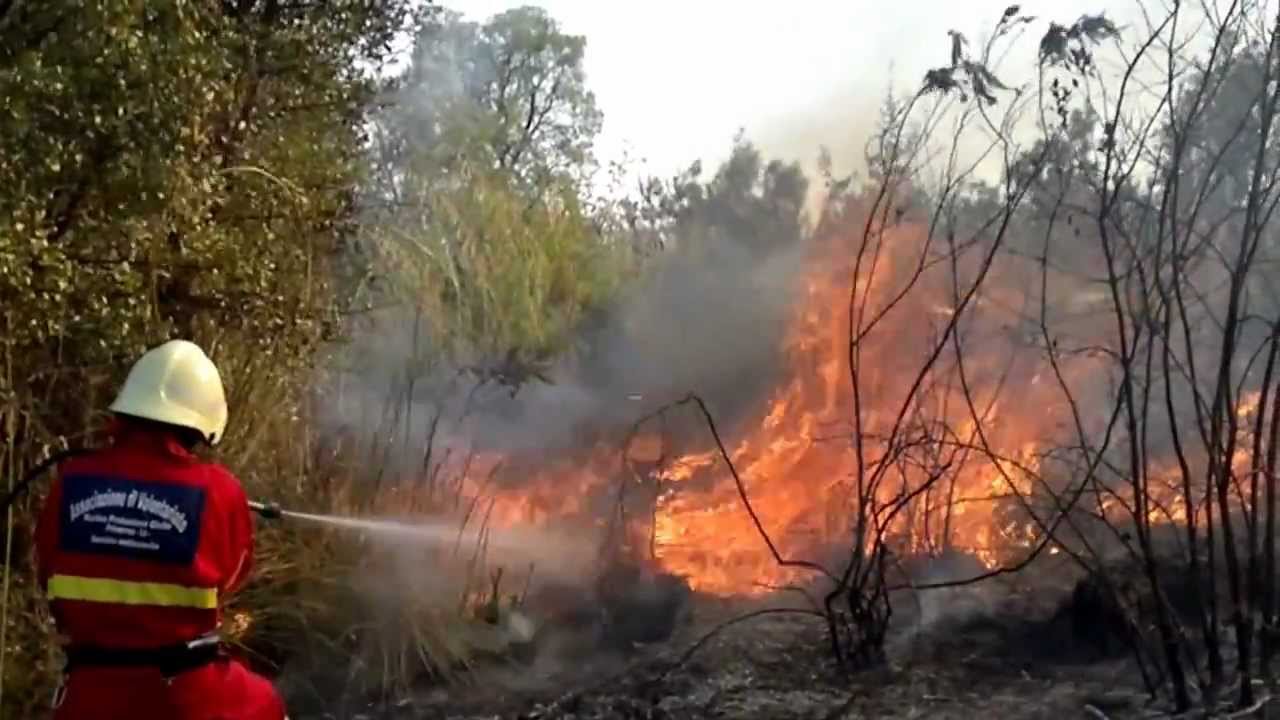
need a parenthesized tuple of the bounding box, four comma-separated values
(378, 6, 602, 192)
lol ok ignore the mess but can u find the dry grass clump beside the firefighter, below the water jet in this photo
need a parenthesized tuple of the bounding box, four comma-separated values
(230, 520, 474, 710)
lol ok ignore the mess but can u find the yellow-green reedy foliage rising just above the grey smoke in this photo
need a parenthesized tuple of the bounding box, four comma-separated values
(376, 169, 622, 371)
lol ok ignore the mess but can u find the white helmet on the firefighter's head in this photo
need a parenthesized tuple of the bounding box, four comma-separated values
(111, 340, 227, 445)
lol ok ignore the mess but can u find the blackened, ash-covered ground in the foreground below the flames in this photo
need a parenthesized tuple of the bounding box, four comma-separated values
(350, 591, 1158, 720)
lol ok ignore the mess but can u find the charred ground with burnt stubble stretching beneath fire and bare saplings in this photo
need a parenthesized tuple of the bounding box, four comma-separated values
(280, 543, 1280, 720)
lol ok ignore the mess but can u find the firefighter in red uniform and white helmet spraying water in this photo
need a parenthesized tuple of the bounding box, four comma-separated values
(36, 340, 285, 720)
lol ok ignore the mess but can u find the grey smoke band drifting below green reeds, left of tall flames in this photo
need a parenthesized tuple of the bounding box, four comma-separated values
(323, 198, 808, 468)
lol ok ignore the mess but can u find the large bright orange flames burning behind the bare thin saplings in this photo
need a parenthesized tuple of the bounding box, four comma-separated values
(455, 199, 1264, 594)
